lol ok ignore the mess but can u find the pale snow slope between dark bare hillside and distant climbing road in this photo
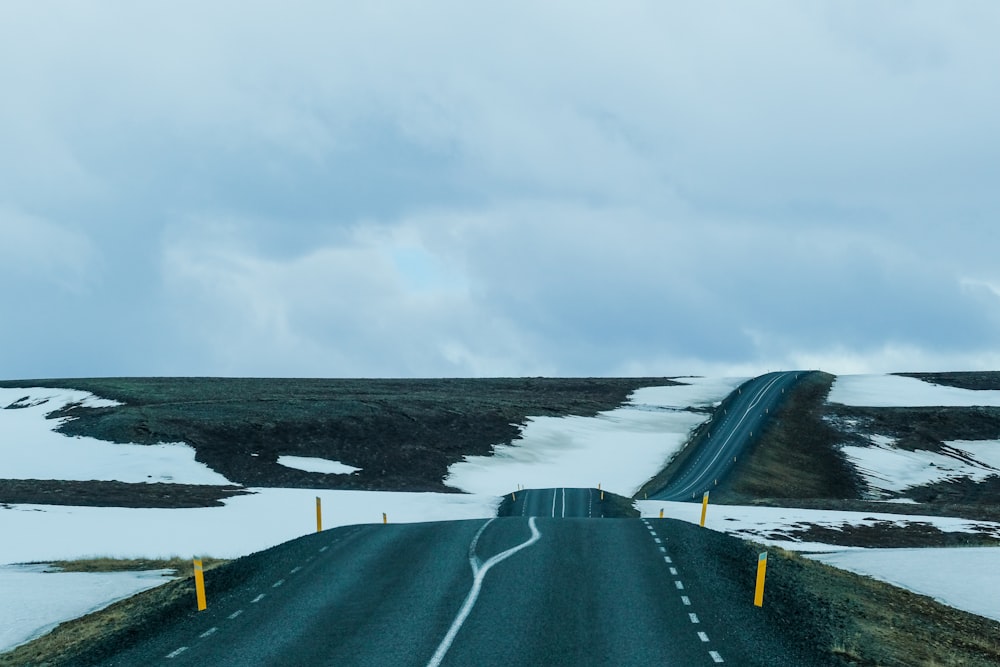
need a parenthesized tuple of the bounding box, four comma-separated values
(445, 378, 746, 496)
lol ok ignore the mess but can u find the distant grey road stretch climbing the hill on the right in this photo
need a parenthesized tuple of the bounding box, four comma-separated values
(649, 371, 811, 501)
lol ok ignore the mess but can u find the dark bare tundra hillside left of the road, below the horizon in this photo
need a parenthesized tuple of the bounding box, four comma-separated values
(0, 378, 676, 507)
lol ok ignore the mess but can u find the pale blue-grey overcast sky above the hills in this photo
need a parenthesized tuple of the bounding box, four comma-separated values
(0, 0, 1000, 378)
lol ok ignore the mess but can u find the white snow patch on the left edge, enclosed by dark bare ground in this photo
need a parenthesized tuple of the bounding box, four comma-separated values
(0, 388, 232, 485)
